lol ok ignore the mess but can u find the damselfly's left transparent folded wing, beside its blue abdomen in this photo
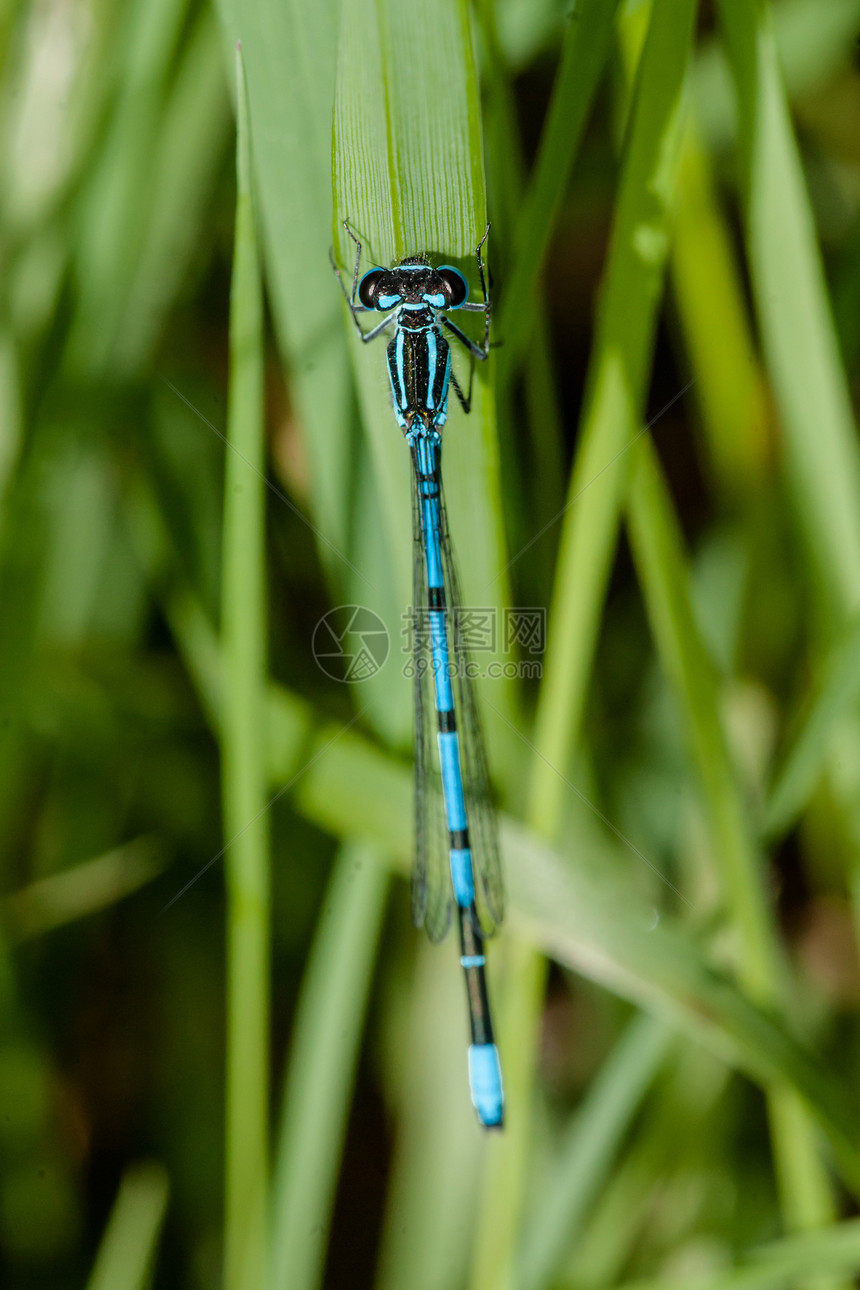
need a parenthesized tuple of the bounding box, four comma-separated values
(413, 459, 454, 942)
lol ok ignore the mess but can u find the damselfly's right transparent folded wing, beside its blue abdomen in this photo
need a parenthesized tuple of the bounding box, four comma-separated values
(440, 464, 504, 938)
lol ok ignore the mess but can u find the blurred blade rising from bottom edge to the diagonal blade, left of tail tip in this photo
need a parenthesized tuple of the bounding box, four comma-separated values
(269, 845, 387, 1290)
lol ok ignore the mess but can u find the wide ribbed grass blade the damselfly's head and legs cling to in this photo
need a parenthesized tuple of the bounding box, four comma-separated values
(331, 0, 512, 747)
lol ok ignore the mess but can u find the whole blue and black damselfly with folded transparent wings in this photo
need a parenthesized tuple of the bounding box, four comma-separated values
(331, 221, 504, 1127)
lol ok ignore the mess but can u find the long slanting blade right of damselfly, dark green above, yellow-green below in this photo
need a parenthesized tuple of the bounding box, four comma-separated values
(529, 0, 695, 835)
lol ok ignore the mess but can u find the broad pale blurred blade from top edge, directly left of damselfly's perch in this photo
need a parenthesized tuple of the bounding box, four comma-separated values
(218, 0, 355, 570)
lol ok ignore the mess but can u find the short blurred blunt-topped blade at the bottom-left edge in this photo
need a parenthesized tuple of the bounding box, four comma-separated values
(86, 1164, 169, 1290)
